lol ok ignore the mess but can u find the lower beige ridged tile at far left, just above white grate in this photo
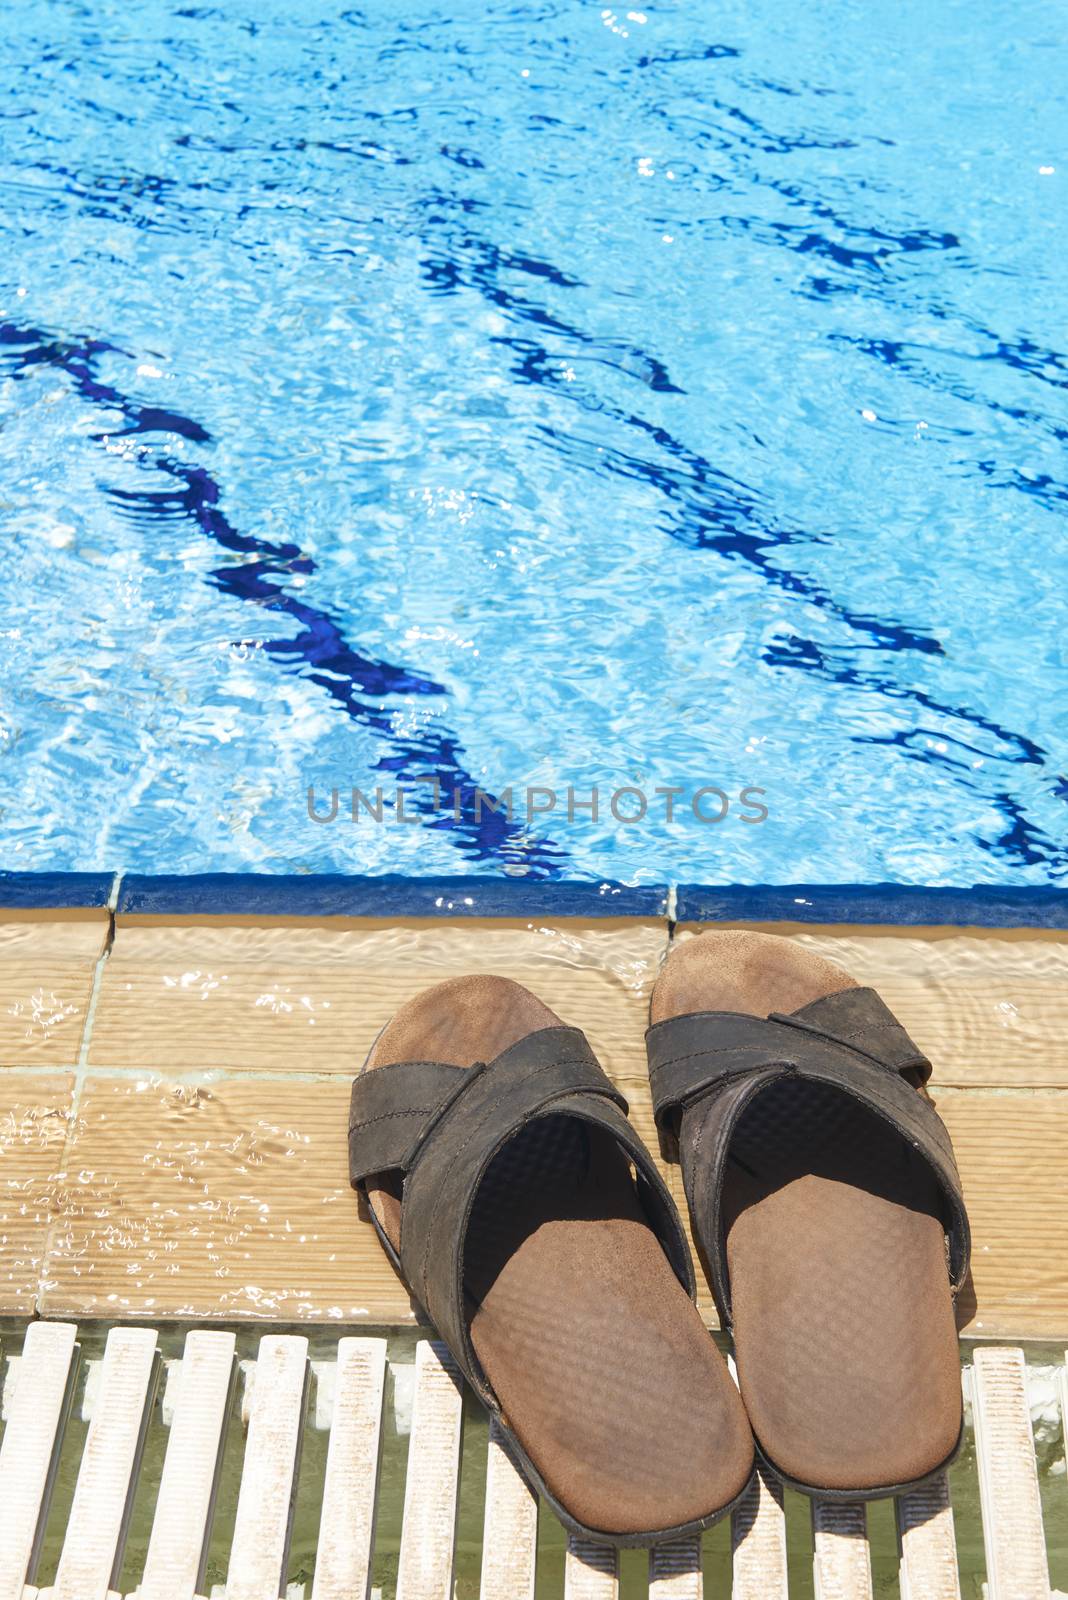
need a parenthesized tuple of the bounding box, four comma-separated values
(0, 1070, 74, 1314)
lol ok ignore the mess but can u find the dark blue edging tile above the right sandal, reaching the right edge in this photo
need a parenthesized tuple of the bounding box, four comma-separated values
(675, 883, 1068, 930)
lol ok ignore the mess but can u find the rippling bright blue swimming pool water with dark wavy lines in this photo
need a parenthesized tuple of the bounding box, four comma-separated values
(0, 0, 1068, 885)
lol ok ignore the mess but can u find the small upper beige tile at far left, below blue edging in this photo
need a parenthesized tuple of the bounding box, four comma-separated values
(0, 910, 109, 1067)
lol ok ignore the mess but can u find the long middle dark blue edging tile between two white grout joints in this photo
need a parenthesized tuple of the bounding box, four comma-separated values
(117, 872, 668, 917)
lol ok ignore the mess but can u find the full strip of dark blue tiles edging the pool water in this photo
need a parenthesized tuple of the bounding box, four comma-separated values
(0, 872, 1068, 930)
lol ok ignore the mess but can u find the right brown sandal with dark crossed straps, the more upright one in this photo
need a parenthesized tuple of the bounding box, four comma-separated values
(648, 931, 969, 1499)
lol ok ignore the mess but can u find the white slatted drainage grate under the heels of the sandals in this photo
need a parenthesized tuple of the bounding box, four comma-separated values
(0, 1322, 1068, 1600)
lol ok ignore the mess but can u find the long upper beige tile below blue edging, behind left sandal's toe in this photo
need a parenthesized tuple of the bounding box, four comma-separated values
(90, 918, 667, 1074)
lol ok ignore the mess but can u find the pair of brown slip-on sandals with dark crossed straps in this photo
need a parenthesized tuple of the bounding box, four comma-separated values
(349, 933, 969, 1546)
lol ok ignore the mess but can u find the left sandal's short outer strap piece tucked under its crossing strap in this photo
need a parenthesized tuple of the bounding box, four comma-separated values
(349, 1061, 470, 1184)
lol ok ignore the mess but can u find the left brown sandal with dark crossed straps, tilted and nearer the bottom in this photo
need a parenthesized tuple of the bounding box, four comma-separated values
(349, 978, 753, 1546)
